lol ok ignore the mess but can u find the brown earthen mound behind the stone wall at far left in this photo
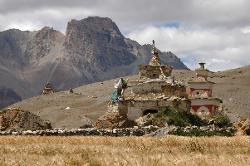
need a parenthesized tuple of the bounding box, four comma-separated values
(0, 108, 52, 131)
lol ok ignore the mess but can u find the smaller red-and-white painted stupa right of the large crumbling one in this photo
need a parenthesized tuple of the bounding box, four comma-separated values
(187, 63, 222, 117)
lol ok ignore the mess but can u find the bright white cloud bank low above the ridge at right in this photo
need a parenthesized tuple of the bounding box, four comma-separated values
(128, 26, 250, 71)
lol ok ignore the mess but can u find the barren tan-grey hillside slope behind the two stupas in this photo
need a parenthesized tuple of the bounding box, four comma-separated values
(7, 66, 250, 128)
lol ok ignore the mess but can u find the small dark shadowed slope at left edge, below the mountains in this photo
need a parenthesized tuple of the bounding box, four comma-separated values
(0, 87, 22, 108)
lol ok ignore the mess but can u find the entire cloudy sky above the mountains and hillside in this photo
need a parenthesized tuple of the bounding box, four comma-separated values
(0, 0, 250, 71)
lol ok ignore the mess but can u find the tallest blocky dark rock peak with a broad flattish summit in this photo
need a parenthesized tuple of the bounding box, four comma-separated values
(64, 17, 135, 72)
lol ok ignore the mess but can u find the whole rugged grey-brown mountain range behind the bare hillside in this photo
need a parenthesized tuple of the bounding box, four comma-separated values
(0, 17, 187, 107)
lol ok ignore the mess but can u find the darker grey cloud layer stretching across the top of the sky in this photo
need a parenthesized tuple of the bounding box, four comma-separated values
(0, 0, 250, 31)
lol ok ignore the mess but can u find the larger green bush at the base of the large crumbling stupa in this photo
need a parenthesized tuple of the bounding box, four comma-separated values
(152, 107, 206, 127)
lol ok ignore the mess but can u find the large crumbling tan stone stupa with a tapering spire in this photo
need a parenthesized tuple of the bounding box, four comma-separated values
(108, 41, 190, 120)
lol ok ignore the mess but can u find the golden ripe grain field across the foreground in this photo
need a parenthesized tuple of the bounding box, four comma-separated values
(0, 136, 250, 166)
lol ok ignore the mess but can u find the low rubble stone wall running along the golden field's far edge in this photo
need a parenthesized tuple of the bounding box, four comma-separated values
(0, 125, 236, 137)
